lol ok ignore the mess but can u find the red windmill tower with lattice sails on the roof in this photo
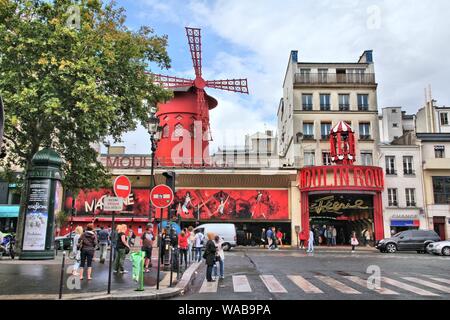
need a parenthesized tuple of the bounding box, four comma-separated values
(153, 27, 248, 166)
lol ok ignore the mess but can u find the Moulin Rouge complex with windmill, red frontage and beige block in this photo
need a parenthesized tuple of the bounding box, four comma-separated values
(62, 28, 385, 245)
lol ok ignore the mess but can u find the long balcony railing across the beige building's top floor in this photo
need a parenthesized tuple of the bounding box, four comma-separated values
(295, 73, 375, 85)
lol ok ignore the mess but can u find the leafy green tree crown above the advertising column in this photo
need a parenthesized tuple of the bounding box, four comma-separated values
(0, 0, 170, 192)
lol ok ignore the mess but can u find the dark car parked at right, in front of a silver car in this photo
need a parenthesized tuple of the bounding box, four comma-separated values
(376, 230, 440, 253)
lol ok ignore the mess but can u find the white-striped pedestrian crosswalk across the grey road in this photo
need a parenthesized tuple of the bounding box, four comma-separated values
(199, 273, 450, 297)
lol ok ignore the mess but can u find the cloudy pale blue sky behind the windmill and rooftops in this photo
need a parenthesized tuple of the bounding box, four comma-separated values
(107, 0, 450, 154)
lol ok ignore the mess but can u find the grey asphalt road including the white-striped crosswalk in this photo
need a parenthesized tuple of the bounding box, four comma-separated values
(175, 249, 450, 300)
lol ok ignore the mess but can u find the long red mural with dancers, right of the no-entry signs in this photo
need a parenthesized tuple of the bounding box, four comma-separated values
(175, 189, 289, 220)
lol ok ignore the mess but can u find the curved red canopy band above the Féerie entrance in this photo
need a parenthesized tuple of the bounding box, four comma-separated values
(299, 166, 384, 191)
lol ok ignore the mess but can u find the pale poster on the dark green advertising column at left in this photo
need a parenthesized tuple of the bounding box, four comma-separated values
(23, 179, 50, 251)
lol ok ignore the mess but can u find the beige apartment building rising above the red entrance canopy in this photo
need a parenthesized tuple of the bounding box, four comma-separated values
(277, 51, 379, 168)
